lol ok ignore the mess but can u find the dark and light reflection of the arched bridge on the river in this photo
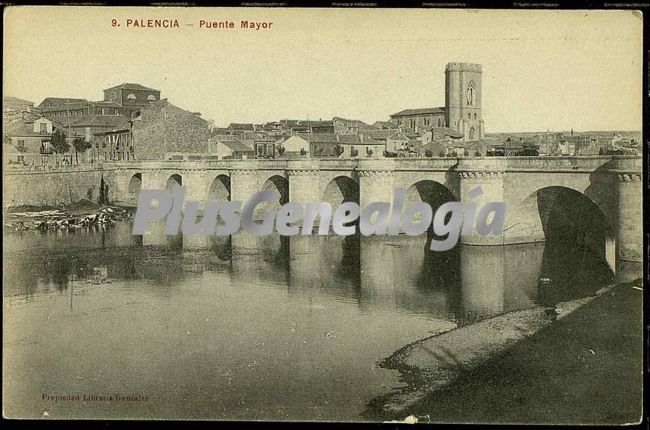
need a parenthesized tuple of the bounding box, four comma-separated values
(5, 218, 613, 325)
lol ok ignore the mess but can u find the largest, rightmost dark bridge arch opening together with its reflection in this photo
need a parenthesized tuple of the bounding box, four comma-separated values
(518, 186, 614, 304)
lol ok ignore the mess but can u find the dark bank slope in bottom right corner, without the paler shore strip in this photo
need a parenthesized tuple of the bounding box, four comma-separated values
(374, 282, 643, 424)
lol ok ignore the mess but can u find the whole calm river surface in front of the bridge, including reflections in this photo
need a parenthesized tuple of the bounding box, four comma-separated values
(3, 221, 612, 420)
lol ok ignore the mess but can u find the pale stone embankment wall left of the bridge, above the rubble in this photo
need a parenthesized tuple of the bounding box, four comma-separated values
(2, 166, 102, 208)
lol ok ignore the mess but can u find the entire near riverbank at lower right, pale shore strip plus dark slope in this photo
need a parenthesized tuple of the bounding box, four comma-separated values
(364, 280, 643, 424)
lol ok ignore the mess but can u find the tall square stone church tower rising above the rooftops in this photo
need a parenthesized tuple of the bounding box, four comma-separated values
(445, 63, 484, 142)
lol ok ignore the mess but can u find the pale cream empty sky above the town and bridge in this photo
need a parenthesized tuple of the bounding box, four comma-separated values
(3, 6, 643, 133)
